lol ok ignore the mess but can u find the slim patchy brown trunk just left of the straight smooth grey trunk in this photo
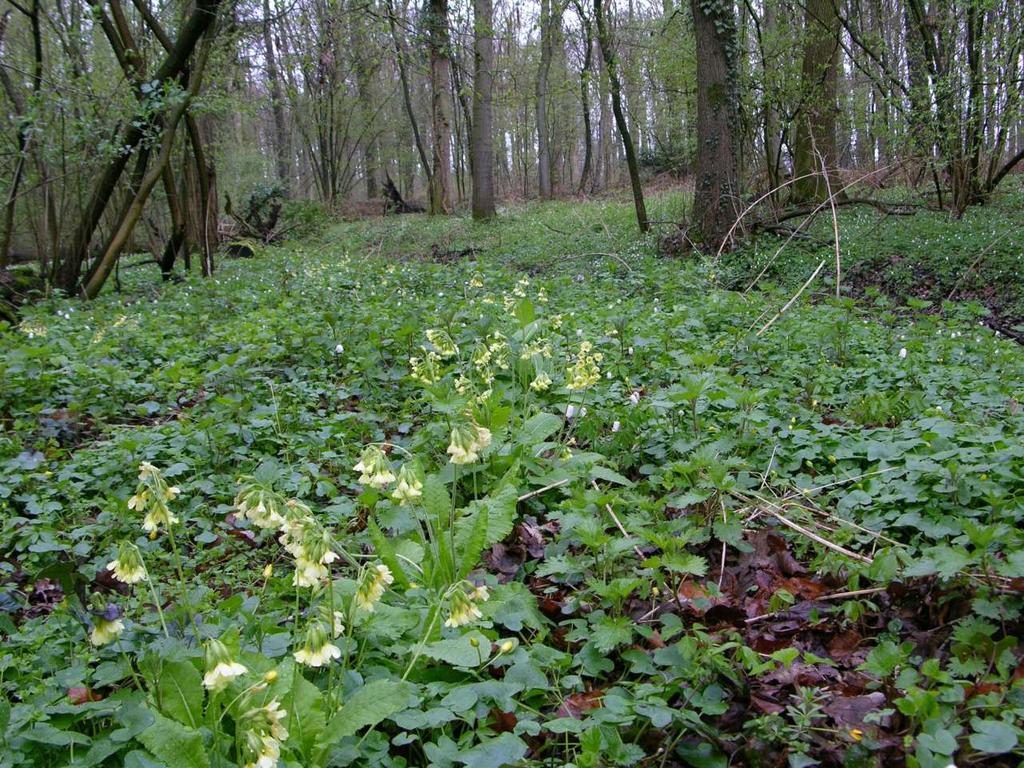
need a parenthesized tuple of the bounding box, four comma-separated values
(427, 0, 452, 214)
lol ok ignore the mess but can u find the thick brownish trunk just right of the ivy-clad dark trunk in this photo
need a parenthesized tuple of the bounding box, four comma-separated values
(793, 0, 841, 203)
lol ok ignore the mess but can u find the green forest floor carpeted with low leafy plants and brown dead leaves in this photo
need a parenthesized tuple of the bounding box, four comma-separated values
(0, 188, 1024, 768)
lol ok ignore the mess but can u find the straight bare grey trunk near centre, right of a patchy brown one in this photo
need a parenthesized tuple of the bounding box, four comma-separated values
(472, 0, 495, 219)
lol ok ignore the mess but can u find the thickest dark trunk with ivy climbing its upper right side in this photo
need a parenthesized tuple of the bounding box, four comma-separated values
(690, 0, 739, 250)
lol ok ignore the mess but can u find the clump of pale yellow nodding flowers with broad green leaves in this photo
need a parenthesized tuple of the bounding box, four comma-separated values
(59, 279, 618, 768)
